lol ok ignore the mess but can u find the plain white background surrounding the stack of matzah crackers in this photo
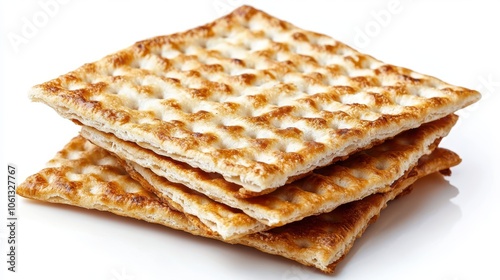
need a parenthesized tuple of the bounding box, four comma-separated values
(0, 0, 500, 280)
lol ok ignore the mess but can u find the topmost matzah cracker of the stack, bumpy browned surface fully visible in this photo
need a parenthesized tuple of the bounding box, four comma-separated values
(30, 6, 480, 194)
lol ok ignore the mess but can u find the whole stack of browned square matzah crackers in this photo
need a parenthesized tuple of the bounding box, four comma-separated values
(17, 6, 480, 273)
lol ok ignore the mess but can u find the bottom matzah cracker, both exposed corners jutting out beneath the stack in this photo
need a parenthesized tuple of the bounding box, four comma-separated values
(17, 137, 460, 272)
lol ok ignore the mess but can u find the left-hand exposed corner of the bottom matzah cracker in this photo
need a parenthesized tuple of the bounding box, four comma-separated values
(17, 137, 212, 235)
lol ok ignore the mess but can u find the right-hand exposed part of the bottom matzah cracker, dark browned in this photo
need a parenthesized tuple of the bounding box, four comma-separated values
(238, 148, 461, 273)
